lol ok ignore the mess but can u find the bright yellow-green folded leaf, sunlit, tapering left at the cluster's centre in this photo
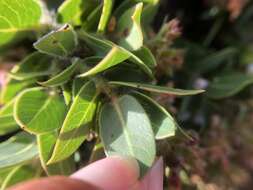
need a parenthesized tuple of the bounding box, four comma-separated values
(79, 46, 130, 77)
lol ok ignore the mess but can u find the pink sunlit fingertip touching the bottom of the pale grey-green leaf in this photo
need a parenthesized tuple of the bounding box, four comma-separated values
(71, 156, 140, 190)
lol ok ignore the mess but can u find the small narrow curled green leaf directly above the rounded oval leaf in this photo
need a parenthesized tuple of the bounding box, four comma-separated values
(39, 59, 79, 87)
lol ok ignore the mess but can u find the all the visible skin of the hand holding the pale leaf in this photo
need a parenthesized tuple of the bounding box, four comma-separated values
(9, 157, 163, 190)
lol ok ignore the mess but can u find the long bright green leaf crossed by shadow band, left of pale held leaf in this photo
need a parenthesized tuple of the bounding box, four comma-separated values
(47, 81, 98, 164)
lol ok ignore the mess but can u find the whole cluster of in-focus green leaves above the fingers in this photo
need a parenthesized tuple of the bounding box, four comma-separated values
(0, 0, 207, 189)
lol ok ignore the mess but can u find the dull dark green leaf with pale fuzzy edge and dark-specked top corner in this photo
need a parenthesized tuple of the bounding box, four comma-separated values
(33, 24, 77, 57)
